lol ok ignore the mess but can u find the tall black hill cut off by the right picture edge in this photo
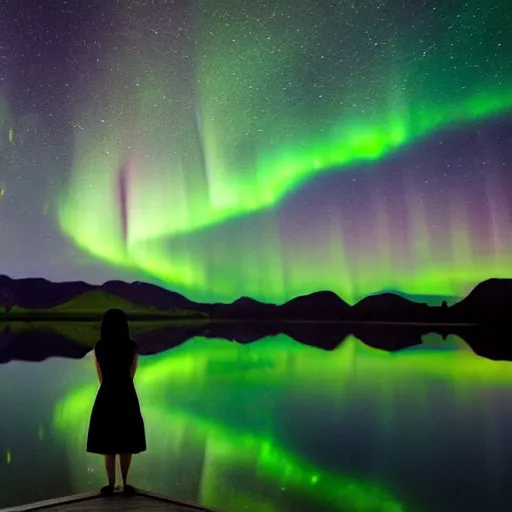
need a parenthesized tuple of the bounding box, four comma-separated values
(449, 278, 512, 323)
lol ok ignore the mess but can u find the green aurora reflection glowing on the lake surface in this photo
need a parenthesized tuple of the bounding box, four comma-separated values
(54, 335, 512, 512)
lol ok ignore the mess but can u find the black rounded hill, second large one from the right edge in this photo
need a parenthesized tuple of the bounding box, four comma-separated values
(353, 293, 430, 322)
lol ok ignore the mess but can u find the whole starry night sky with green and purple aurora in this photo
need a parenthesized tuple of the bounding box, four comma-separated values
(0, 0, 512, 303)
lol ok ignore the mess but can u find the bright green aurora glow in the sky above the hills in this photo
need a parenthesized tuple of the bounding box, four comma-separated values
(57, 1, 512, 302)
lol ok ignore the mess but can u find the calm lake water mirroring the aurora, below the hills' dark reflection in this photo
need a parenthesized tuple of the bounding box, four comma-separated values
(0, 328, 512, 512)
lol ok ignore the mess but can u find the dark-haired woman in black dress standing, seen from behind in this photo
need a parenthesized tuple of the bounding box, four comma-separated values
(87, 309, 146, 495)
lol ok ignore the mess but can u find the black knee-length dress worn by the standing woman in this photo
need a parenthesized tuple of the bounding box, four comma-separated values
(87, 340, 146, 455)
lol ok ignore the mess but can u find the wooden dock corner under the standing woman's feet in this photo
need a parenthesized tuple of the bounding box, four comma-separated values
(0, 490, 219, 512)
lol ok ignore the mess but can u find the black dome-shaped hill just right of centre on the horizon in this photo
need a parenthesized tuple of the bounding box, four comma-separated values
(277, 291, 351, 321)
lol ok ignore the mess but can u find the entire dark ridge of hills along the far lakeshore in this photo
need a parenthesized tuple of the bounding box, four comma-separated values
(0, 276, 512, 324)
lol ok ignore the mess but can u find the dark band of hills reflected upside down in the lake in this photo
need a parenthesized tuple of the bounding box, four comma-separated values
(0, 322, 512, 363)
